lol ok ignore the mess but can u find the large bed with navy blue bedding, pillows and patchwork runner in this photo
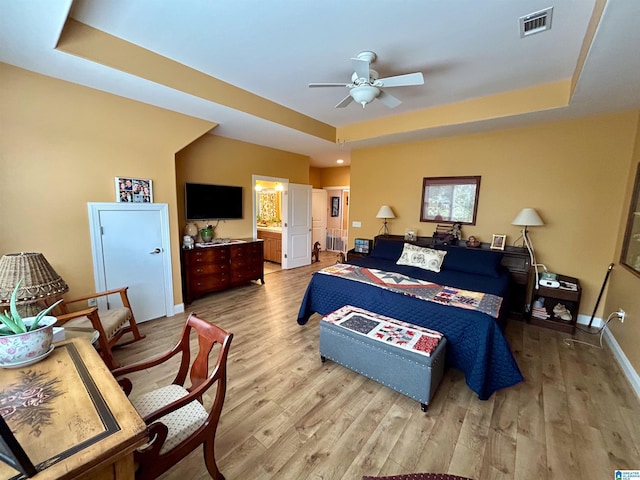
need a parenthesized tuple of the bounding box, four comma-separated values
(298, 238, 523, 400)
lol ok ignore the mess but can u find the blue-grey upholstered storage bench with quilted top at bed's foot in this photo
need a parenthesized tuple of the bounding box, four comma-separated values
(320, 305, 447, 412)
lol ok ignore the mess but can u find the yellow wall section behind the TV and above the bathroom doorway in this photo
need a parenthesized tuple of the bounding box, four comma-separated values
(176, 135, 309, 238)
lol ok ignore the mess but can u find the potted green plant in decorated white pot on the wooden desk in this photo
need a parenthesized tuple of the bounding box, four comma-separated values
(0, 279, 62, 367)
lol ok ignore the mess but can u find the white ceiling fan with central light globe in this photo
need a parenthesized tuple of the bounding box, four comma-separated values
(309, 51, 424, 108)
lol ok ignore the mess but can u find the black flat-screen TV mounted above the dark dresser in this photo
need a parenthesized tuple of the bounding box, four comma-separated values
(184, 183, 242, 220)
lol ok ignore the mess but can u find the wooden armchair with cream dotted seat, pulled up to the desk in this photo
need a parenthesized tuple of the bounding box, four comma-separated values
(112, 313, 233, 480)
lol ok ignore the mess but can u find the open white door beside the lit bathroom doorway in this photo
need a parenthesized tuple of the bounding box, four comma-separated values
(282, 183, 311, 269)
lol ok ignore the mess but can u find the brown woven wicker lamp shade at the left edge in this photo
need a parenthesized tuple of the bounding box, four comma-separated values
(0, 253, 69, 308)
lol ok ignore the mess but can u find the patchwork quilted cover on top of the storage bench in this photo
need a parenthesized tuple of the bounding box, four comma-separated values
(322, 305, 442, 357)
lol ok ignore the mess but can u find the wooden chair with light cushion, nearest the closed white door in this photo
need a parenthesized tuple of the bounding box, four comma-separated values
(56, 287, 145, 370)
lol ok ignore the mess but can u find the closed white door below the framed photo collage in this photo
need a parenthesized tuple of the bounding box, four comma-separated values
(90, 203, 174, 322)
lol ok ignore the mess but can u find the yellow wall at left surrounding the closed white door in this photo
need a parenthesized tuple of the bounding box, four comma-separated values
(0, 63, 215, 303)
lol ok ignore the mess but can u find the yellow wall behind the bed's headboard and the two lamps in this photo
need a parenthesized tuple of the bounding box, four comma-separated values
(349, 112, 638, 324)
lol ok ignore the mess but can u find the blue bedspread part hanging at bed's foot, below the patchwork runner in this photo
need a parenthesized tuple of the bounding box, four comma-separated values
(298, 268, 523, 400)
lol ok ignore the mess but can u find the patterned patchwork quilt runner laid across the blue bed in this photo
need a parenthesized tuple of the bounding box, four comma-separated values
(318, 264, 502, 318)
